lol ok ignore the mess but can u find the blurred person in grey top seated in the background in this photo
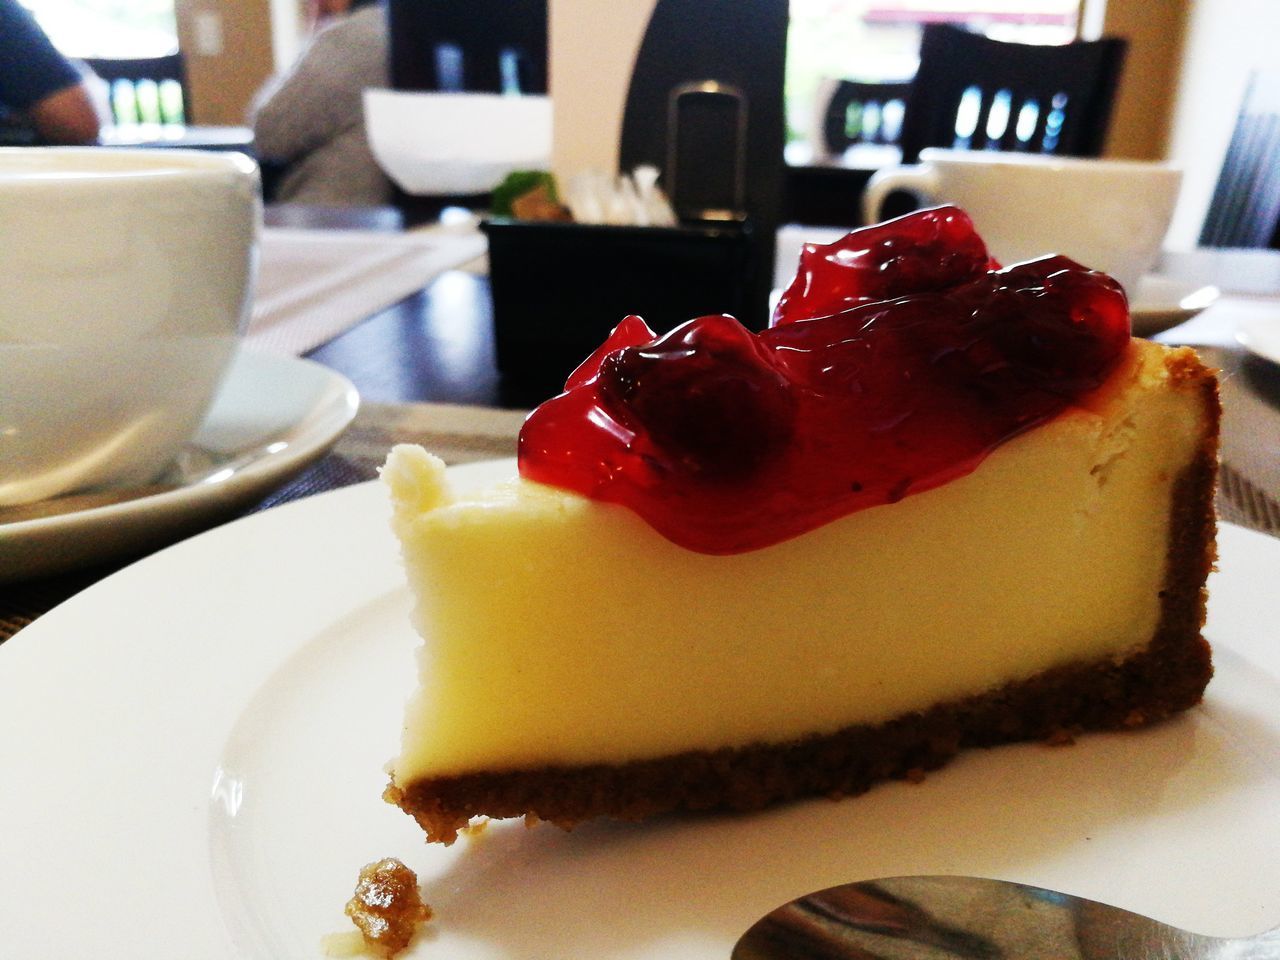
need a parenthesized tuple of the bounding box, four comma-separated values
(250, 0, 392, 206)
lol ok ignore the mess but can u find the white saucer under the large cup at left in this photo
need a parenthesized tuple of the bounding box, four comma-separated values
(0, 349, 360, 582)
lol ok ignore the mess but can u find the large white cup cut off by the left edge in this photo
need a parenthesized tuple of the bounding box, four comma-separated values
(0, 147, 261, 504)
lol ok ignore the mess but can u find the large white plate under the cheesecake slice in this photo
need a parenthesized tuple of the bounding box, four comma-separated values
(0, 462, 1280, 960)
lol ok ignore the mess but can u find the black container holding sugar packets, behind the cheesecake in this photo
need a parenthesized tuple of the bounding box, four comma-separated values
(481, 219, 767, 392)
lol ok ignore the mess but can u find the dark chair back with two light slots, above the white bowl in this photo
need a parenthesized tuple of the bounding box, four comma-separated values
(387, 0, 547, 93)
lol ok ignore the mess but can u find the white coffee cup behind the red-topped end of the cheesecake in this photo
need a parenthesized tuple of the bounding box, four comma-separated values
(863, 148, 1181, 296)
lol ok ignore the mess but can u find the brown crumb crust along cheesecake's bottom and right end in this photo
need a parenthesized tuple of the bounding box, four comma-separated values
(383, 349, 1220, 844)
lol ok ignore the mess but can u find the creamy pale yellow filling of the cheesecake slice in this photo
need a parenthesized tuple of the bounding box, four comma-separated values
(384, 340, 1203, 786)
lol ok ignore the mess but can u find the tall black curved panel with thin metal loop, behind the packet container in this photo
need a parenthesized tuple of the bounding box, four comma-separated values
(620, 0, 787, 326)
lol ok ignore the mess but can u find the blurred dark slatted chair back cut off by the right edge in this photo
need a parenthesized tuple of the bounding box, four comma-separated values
(1199, 73, 1280, 247)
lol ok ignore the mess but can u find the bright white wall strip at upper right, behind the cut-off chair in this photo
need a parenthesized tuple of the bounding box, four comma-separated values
(1167, 0, 1280, 250)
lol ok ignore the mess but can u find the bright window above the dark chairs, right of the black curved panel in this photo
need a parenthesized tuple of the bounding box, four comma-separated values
(786, 0, 1080, 163)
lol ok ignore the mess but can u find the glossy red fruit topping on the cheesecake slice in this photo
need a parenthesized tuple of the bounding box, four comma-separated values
(520, 210, 1129, 554)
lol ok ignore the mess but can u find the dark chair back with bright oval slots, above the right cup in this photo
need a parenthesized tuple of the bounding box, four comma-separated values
(901, 23, 1128, 164)
